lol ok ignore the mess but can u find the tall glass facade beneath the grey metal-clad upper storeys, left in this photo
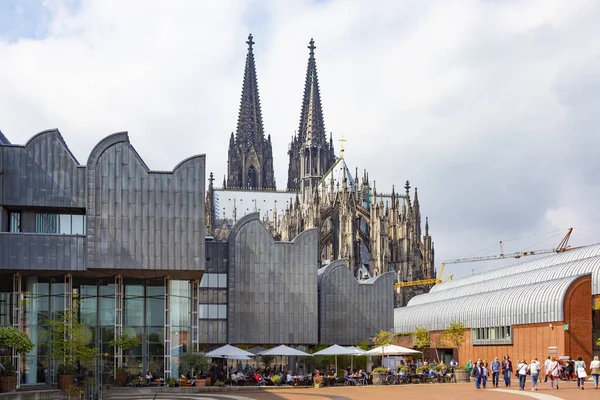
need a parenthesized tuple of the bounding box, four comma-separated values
(8, 275, 192, 385)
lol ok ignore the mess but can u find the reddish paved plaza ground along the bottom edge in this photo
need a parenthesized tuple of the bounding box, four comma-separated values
(110, 382, 600, 400)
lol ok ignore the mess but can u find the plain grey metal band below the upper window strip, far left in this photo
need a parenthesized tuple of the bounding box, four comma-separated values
(0, 232, 85, 271)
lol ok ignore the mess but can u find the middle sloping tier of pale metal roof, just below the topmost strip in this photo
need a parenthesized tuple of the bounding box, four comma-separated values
(407, 257, 600, 307)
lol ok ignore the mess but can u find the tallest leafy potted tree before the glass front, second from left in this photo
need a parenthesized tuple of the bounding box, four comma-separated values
(48, 306, 96, 389)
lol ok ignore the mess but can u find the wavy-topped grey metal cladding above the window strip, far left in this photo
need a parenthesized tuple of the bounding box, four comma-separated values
(2, 130, 86, 208)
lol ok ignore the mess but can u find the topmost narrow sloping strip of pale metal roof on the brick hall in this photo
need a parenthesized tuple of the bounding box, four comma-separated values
(429, 244, 600, 293)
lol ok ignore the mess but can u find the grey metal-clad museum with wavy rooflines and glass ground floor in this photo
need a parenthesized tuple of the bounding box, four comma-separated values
(0, 130, 394, 385)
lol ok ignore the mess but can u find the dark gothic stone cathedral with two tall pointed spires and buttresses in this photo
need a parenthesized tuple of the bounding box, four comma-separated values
(206, 35, 436, 306)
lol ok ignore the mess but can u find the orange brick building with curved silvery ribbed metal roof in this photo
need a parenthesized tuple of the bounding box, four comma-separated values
(394, 245, 600, 365)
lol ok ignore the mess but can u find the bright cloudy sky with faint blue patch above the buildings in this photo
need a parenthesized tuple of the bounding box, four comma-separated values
(0, 0, 600, 276)
